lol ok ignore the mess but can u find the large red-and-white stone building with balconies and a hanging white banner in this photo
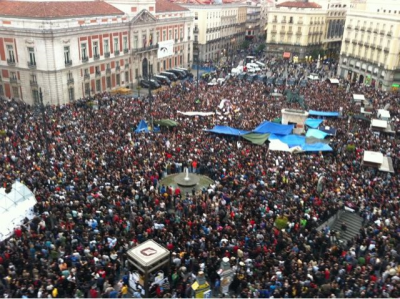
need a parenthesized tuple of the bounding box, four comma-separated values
(0, 0, 193, 105)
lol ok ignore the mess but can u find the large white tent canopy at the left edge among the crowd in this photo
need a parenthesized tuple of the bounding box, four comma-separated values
(0, 182, 36, 241)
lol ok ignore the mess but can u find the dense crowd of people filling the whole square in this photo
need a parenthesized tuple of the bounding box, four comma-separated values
(0, 57, 400, 298)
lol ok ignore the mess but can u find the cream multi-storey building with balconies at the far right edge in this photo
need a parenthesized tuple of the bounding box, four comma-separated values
(338, 0, 400, 90)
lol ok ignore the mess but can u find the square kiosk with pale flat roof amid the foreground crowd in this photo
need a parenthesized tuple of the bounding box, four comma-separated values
(127, 240, 170, 298)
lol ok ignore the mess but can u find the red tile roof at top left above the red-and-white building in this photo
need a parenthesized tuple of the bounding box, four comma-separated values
(0, 0, 124, 19)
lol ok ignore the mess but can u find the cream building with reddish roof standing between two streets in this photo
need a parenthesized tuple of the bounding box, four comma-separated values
(266, 1, 326, 59)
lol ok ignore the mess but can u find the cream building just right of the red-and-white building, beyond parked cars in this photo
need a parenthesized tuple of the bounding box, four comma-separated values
(182, 4, 247, 63)
